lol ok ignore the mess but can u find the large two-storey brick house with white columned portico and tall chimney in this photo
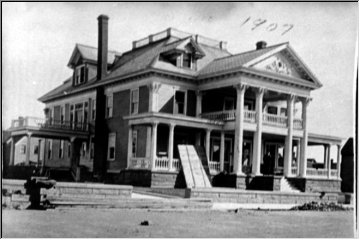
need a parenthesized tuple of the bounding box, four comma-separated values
(4, 15, 341, 191)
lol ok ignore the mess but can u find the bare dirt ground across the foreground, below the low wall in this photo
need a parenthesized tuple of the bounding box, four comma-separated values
(2, 209, 354, 238)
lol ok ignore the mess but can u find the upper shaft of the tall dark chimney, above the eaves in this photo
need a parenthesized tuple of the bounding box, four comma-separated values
(96, 15, 109, 81)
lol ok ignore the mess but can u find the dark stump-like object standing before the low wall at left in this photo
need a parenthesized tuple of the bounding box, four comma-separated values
(24, 177, 56, 209)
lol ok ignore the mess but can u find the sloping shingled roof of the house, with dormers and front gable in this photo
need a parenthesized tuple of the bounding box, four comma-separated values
(39, 29, 321, 102)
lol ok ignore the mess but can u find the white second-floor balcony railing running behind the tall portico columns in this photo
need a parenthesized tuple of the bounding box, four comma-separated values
(201, 110, 303, 129)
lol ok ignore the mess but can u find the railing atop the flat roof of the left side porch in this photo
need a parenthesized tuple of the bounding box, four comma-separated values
(11, 117, 89, 131)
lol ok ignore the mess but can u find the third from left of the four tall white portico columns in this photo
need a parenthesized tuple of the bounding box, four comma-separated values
(284, 95, 295, 177)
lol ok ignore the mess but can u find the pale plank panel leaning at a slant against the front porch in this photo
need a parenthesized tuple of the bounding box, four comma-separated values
(178, 145, 211, 188)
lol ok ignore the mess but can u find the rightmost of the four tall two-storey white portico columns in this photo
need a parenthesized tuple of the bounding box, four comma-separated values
(300, 98, 310, 178)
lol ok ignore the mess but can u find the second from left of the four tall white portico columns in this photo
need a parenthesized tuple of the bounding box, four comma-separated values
(251, 88, 264, 175)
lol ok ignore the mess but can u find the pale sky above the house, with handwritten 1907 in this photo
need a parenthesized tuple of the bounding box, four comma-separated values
(2, 2, 359, 139)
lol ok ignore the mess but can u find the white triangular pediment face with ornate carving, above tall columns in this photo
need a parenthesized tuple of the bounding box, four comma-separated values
(252, 52, 307, 79)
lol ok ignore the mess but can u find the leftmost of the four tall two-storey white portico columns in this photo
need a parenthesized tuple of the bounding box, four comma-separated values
(233, 84, 246, 175)
